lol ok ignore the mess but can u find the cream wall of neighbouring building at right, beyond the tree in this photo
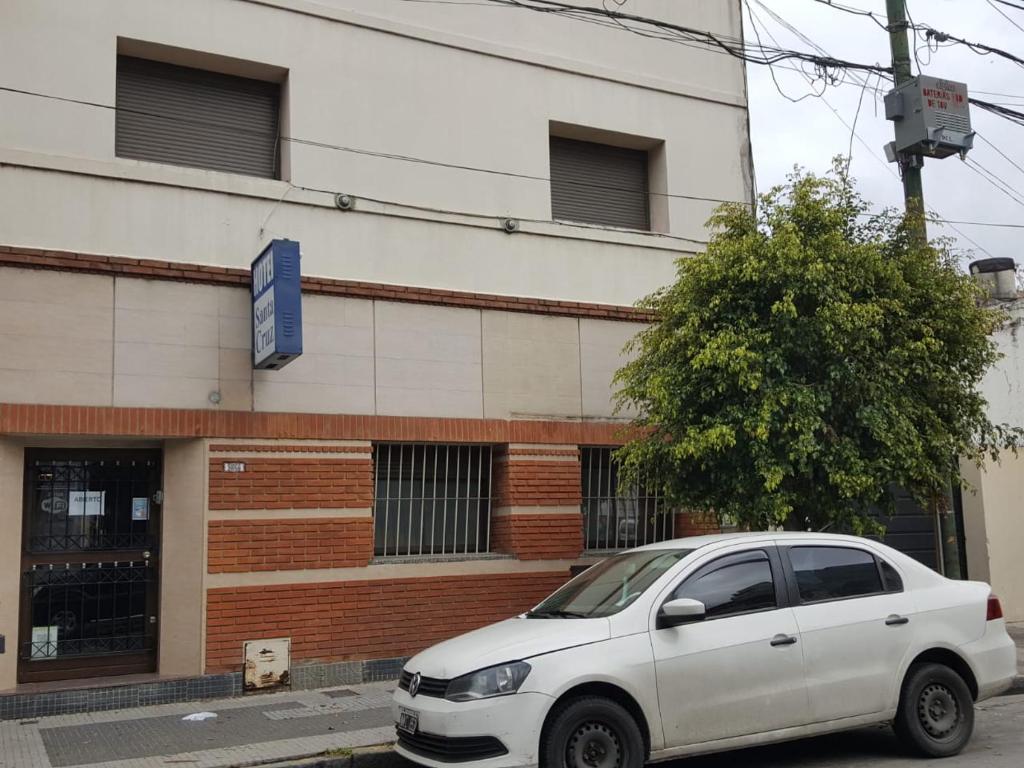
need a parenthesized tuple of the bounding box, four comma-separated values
(961, 299, 1024, 622)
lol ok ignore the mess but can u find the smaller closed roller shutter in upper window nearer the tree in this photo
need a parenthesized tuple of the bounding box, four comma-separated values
(551, 136, 650, 229)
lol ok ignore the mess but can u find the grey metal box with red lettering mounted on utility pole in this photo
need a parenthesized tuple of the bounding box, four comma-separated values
(885, 75, 974, 158)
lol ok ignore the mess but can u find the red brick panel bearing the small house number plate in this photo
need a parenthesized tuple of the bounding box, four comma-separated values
(210, 457, 374, 509)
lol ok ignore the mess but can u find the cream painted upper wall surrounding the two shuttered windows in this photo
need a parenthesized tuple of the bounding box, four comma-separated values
(0, 0, 751, 304)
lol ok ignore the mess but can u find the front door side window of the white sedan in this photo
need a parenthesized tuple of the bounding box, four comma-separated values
(670, 550, 778, 618)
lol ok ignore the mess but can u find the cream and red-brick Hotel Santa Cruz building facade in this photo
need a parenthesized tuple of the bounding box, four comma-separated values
(0, 0, 752, 696)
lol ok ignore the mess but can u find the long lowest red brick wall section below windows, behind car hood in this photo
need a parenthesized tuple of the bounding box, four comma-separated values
(206, 570, 569, 673)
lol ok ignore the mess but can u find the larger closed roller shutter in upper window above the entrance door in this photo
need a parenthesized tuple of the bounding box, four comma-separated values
(115, 56, 281, 178)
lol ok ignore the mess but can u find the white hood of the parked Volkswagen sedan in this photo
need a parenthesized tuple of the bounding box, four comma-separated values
(406, 616, 611, 680)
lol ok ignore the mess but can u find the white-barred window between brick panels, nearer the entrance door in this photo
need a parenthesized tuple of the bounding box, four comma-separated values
(374, 443, 490, 557)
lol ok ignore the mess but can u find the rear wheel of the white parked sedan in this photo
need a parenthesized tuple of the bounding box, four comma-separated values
(893, 664, 974, 758)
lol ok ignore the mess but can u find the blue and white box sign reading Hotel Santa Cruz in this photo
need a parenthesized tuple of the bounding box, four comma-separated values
(252, 240, 302, 370)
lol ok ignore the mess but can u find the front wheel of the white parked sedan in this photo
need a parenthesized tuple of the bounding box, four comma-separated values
(541, 696, 646, 768)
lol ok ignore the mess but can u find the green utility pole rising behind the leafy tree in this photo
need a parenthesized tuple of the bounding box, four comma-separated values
(886, 0, 963, 579)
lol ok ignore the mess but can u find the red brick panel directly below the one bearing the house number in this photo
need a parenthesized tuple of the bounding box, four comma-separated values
(207, 517, 374, 573)
